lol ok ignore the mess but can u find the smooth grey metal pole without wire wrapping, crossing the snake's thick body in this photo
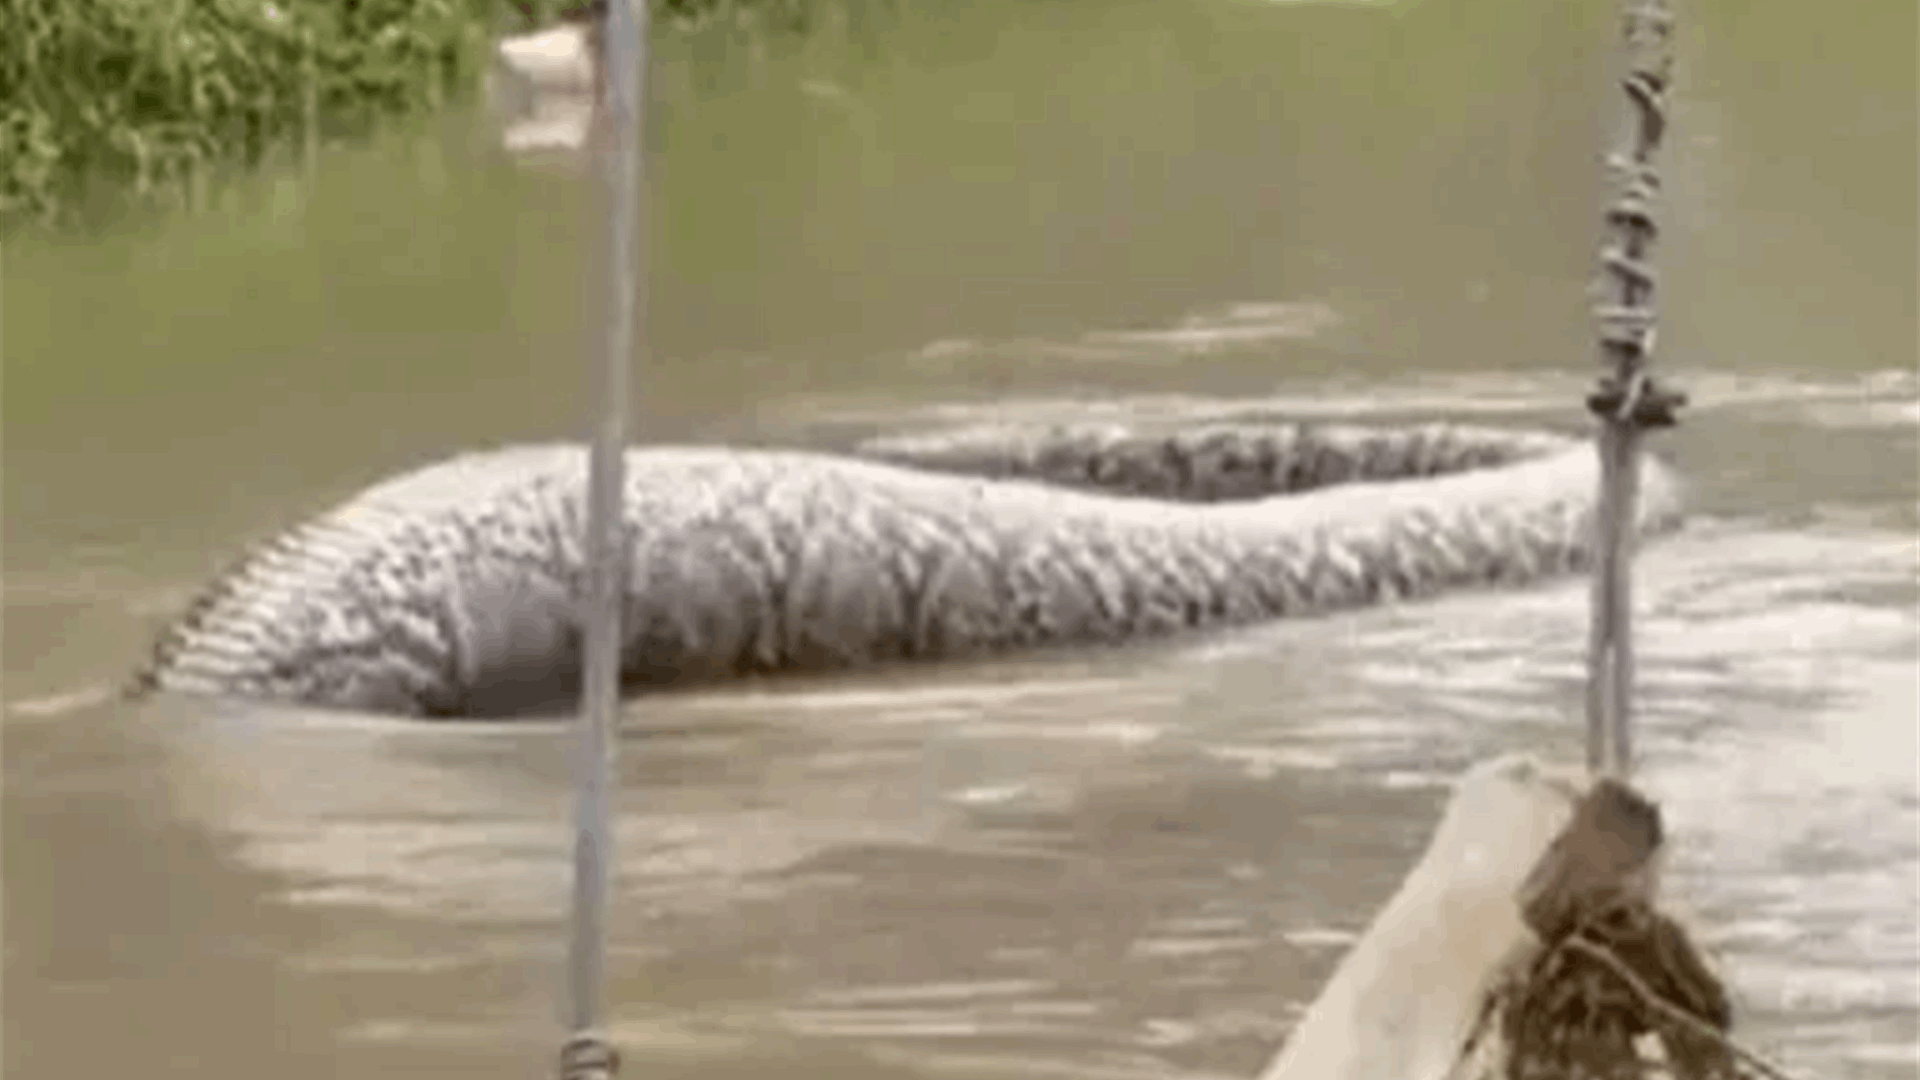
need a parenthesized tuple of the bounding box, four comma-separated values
(561, 0, 647, 1080)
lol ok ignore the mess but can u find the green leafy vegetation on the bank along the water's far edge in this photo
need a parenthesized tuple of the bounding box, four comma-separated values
(0, 0, 829, 231)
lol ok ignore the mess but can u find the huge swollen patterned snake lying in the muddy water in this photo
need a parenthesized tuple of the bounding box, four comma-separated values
(132, 425, 1680, 717)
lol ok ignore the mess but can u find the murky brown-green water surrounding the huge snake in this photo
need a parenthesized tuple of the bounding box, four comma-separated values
(0, 0, 1920, 1080)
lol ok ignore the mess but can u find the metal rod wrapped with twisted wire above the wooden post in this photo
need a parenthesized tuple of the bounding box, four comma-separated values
(1586, 0, 1686, 778)
